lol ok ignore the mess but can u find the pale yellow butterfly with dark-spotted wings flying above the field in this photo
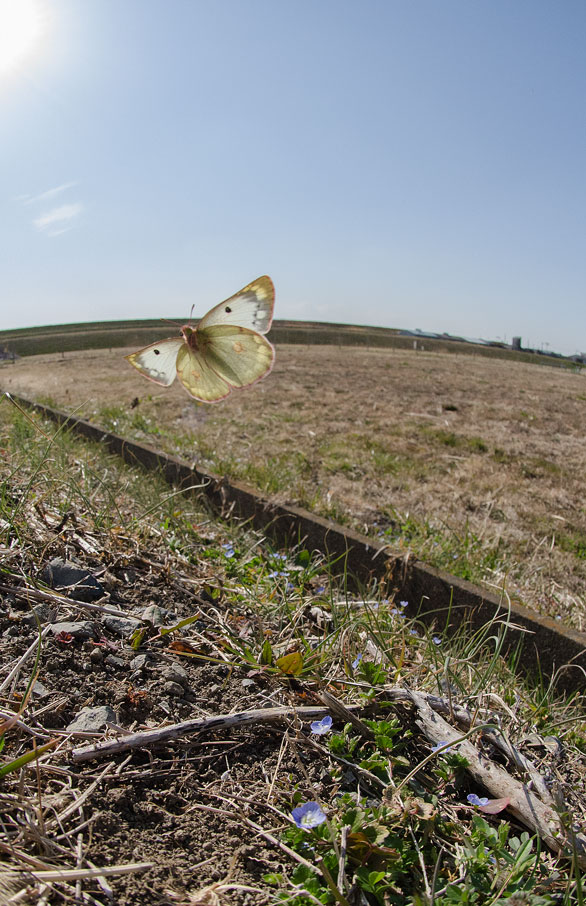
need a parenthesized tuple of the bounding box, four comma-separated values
(125, 277, 275, 403)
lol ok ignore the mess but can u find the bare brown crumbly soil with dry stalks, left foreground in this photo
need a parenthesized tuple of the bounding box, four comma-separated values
(0, 508, 338, 906)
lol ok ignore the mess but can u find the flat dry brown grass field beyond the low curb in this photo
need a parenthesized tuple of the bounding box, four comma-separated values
(0, 346, 586, 629)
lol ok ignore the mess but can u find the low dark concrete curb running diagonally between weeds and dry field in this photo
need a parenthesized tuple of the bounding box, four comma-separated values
(6, 394, 586, 692)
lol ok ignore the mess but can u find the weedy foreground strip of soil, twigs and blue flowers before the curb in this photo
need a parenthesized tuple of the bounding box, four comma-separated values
(0, 400, 586, 906)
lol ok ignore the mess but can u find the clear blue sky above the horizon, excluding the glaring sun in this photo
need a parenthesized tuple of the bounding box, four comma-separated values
(0, 0, 586, 353)
